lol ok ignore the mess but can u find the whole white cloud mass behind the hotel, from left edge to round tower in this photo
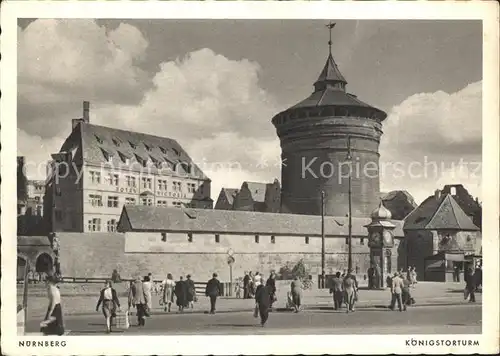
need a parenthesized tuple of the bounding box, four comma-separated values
(18, 20, 280, 198)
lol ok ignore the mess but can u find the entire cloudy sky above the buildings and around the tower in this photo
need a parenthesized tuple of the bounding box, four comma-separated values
(18, 19, 482, 202)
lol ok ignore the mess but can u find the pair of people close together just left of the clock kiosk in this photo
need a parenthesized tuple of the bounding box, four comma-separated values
(330, 270, 358, 313)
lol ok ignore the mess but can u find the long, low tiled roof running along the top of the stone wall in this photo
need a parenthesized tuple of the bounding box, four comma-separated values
(118, 205, 404, 237)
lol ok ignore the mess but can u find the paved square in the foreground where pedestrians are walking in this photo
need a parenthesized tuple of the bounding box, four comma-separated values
(22, 282, 481, 335)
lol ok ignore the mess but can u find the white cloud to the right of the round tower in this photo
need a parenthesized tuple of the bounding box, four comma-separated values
(380, 82, 482, 201)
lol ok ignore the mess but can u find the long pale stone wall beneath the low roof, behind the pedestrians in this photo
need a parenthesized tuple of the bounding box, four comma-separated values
(58, 233, 386, 282)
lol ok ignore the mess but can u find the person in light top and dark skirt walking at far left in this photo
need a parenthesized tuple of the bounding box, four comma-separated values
(40, 275, 64, 336)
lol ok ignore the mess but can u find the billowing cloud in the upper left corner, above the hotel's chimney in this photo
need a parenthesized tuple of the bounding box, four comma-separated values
(18, 19, 148, 138)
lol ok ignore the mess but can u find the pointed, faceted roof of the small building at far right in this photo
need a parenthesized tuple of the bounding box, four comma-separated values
(404, 194, 479, 231)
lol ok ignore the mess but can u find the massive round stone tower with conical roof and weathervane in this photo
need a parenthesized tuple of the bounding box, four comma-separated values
(272, 25, 387, 217)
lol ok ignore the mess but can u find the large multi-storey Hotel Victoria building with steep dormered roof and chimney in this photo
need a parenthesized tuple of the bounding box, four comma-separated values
(46, 102, 213, 232)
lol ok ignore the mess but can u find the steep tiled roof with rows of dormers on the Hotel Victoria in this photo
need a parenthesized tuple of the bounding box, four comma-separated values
(80, 123, 208, 179)
